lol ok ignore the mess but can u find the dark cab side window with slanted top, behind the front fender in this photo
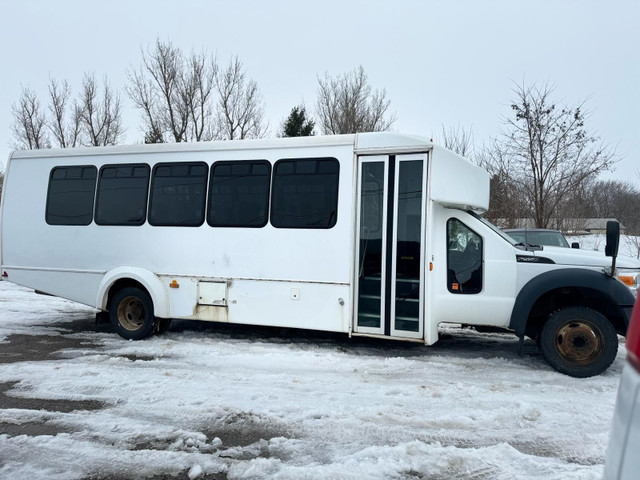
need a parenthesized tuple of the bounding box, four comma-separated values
(447, 218, 482, 294)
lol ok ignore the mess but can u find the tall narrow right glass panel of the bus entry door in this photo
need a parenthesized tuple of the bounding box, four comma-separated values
(395, 160, 423, 332)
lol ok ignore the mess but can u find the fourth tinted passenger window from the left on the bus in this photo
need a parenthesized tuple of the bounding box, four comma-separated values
(207, 160, 271, 227)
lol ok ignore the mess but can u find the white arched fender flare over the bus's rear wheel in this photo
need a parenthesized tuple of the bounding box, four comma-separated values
(96, 267, 169, 318)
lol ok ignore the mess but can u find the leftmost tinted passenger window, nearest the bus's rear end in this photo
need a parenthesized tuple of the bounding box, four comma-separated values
(45, 166, 98, 225)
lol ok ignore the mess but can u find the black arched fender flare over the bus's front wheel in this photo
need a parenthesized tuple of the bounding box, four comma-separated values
(509, 268, 635, 337)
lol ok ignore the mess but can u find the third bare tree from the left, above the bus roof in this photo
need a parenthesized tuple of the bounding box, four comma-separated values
(80, 74, 124, 147)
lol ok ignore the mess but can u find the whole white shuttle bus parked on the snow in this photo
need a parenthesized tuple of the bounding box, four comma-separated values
(0, 133, 640, 377)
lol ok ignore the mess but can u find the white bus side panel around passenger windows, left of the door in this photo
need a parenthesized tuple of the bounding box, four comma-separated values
(2, 144, 354, 332)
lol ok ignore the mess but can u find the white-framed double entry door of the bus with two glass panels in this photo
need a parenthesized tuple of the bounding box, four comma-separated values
(354, 154, 427, 338)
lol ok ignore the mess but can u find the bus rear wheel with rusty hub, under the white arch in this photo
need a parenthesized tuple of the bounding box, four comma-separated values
(109, 287, 156, 340)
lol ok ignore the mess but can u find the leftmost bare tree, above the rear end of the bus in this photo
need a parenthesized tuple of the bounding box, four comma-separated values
(11, 87, 51, 150)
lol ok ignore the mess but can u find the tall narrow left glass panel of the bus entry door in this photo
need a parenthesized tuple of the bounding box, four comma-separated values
(358, 162, 384, 328)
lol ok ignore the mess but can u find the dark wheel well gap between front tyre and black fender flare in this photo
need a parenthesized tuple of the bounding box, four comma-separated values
(525, 287, 627, 338)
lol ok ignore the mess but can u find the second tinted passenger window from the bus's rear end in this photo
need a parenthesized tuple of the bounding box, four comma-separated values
(96, 164, 150, 225)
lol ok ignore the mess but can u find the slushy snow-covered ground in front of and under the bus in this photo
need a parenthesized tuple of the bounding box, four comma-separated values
(0, 282, 625, 480)
